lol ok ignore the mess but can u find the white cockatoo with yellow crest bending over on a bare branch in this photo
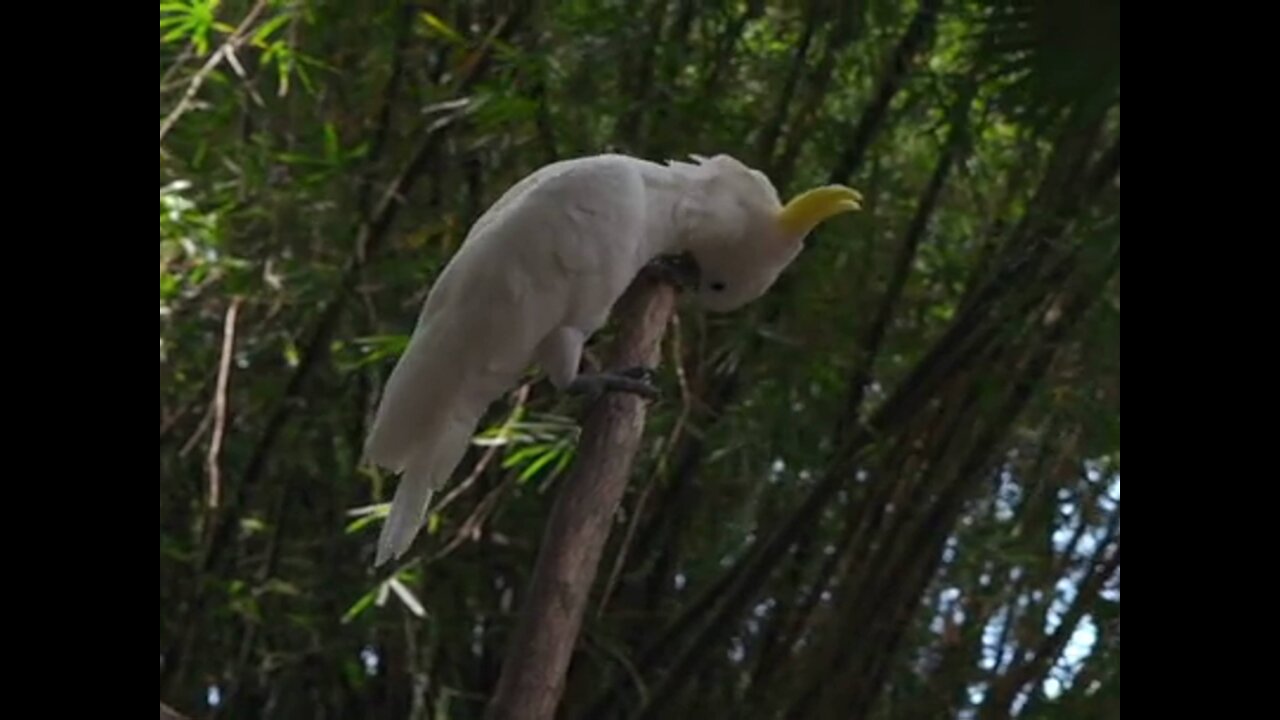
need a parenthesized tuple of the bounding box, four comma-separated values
(365, 155, 860, 565)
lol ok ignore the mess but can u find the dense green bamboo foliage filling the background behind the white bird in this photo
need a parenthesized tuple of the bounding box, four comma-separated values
(160, 0, 1120, 719)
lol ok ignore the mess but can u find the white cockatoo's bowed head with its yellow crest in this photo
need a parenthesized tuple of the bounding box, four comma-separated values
(678, 155, 861, 313)
